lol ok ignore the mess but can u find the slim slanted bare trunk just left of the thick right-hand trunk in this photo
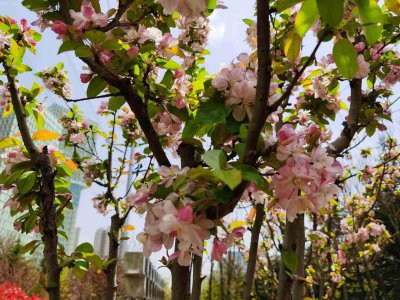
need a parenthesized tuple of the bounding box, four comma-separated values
(243, 203, 264, 300)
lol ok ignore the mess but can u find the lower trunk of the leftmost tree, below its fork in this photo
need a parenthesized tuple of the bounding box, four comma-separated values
(36, 147, 61, 300)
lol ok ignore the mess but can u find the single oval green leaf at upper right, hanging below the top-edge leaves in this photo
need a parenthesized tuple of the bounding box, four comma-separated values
(333, 39, 358, 79)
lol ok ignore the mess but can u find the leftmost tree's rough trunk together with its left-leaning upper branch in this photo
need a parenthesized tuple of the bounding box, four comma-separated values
(3, 63, 61, 300)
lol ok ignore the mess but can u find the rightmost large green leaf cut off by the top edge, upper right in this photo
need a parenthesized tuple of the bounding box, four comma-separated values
(356, 0, 383, 45)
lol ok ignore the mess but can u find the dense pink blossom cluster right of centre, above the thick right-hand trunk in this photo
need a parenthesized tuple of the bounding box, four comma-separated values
(270, 124, 342, 221)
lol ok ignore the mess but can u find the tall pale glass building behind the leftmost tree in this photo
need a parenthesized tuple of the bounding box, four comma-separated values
(0, 104, 86, 259)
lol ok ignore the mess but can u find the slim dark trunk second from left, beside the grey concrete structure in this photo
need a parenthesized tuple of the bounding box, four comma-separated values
(105, 213, 121, 300)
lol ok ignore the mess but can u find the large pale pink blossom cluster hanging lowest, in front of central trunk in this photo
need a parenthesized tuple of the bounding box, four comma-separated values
(134, 166, 220, 266)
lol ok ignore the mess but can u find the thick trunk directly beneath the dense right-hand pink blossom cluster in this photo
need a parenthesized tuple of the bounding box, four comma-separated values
(278, 214, 304, 300)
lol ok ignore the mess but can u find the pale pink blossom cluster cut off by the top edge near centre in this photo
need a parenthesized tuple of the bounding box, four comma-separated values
(158, 0, 208, 16)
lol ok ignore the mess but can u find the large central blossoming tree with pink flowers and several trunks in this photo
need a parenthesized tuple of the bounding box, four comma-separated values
(1, 0, 400, 300)
